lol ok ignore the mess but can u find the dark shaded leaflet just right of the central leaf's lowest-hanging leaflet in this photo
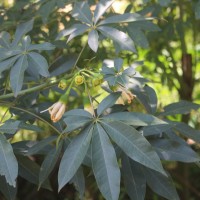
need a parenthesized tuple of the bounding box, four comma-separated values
(122, 154, 146, 200)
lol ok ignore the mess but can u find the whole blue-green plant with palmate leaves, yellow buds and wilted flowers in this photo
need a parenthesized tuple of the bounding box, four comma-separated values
(0, 0, 200, 200)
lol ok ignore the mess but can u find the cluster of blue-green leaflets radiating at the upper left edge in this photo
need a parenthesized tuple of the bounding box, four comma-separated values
(0, 20, 54, 96)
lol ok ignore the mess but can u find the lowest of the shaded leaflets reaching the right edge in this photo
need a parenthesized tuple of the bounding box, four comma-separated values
(150, 139, 200, 163)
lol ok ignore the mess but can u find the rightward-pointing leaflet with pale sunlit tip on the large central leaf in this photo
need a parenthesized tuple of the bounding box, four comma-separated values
(104, 112, 167, 126)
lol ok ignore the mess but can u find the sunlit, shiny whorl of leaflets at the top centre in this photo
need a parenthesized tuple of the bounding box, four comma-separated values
(57, 0, 152, 52)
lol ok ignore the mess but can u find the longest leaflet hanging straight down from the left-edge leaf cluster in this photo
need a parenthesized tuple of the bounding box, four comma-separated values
(10, 55, 28, 97)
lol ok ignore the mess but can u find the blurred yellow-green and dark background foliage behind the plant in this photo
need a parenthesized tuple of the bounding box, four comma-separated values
(0, 0, 200, 200)
